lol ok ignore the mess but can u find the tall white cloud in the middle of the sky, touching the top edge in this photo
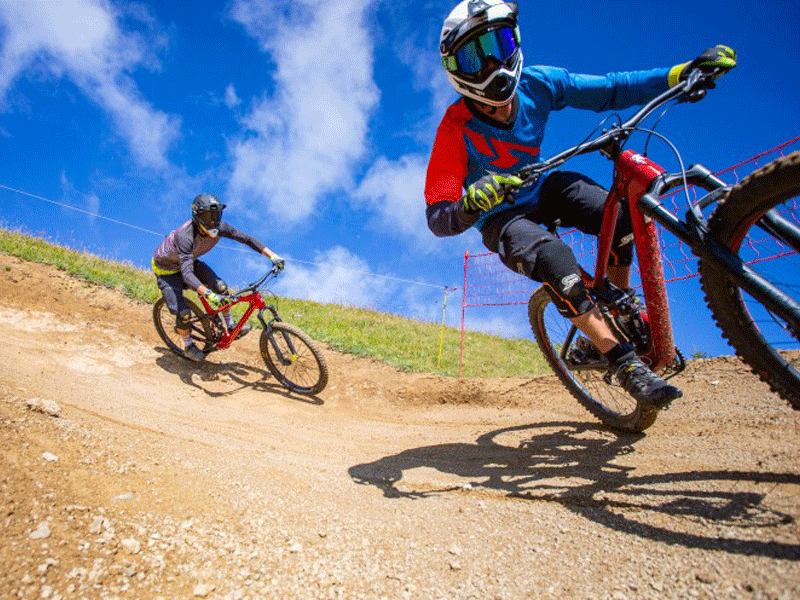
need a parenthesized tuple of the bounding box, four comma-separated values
(230, 0, 379, 222)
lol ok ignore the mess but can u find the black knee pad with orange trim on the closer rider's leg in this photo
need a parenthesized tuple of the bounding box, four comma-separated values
(535, 239, 594, 319)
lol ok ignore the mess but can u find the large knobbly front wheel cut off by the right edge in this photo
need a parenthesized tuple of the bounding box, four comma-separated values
(699, 152, 800, 410)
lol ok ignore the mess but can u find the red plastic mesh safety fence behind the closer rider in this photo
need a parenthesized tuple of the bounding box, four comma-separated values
(458, 136, 800, 377)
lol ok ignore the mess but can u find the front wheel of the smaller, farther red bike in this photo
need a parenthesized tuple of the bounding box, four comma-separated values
(260, 321, 328, 394)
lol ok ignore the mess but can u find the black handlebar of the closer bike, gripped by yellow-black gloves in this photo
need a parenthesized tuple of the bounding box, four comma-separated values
(508, 69, 718, 192)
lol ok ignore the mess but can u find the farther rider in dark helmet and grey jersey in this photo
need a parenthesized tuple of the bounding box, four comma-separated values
(152, 194, 284, 362)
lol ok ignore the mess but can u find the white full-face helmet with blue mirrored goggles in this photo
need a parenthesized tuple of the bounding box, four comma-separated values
(439, 0, 522, 106)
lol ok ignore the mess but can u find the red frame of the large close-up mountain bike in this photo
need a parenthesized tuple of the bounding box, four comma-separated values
(584, 150, 676, 370)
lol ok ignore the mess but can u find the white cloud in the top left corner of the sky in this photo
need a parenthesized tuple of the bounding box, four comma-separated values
(0, 0, 180, 169)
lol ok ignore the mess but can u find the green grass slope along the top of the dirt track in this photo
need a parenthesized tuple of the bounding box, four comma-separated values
(0, 229, 548, 377)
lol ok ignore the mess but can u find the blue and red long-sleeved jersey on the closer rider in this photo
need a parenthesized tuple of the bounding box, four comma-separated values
(425, 66, 669, 236)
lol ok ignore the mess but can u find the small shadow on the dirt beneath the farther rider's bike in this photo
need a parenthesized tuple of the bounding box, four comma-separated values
(155, 346, 325, 406)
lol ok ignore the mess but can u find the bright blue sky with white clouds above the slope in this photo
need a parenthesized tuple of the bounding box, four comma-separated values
(0, 0, 800, 354)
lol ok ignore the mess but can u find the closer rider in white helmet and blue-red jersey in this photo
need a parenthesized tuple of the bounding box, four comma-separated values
(425, 0, 736, 408)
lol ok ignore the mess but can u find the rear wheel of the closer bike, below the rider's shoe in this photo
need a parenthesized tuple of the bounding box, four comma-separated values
(528, 287, 658, 432)
